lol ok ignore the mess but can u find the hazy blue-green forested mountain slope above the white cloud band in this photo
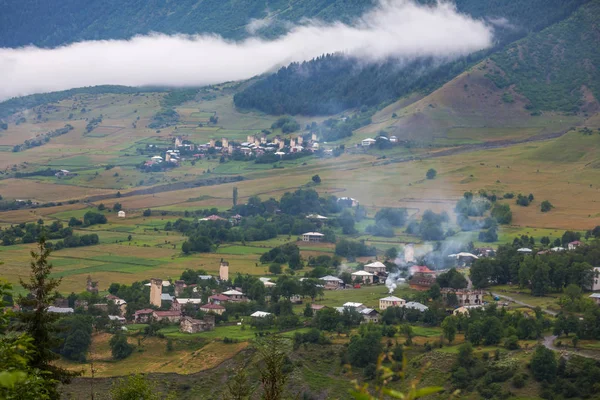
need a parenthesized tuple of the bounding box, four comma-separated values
(0, 0, 373, 47)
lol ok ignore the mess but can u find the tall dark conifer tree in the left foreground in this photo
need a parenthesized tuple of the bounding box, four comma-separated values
(18, 237, 79, 399)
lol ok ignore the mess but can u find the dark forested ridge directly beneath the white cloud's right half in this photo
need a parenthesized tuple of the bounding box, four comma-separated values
(234, 54, 478, 115)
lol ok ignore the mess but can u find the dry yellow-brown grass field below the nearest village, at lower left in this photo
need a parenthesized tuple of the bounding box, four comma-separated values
(57, 333, 248, 377)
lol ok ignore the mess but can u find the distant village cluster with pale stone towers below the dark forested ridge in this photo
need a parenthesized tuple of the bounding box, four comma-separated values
(144, 133, 333, 167)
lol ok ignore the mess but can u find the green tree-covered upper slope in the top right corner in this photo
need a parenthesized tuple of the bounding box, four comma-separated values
(488, 0, 600, 112)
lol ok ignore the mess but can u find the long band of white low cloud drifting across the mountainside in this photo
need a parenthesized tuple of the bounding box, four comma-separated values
(0, 0, 493, 100)
